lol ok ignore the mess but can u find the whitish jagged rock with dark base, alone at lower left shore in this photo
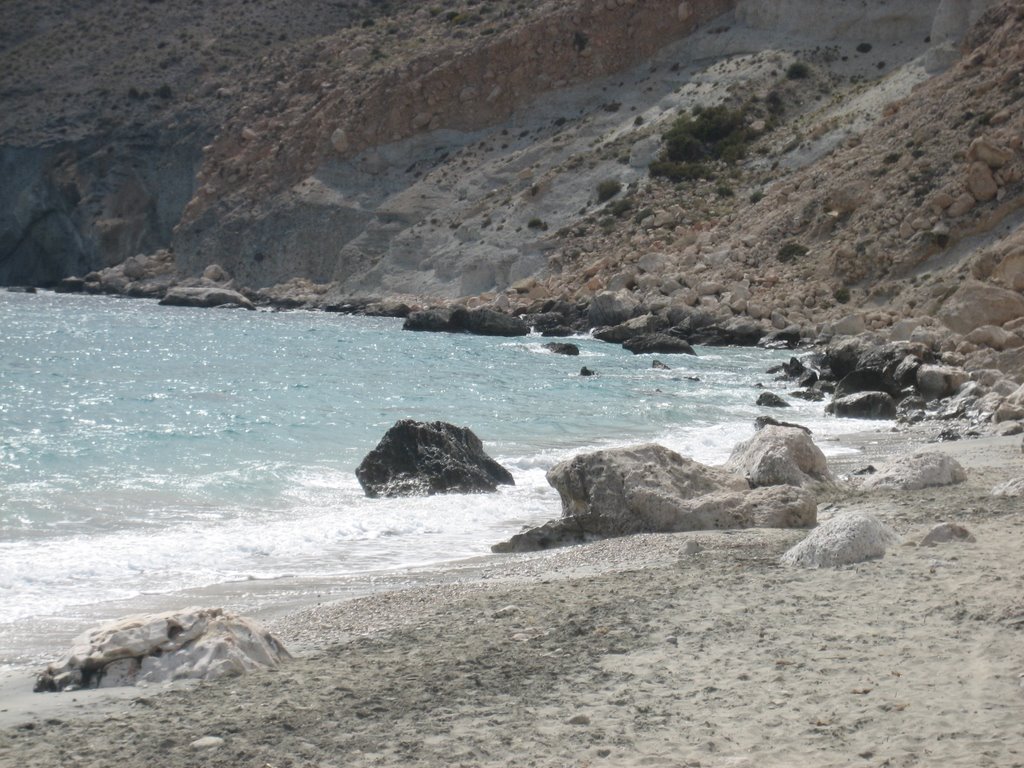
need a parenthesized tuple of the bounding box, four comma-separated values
(36, 608, 291, 691)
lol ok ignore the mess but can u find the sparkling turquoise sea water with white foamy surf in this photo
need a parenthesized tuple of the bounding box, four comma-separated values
(0, 293, 864, 664)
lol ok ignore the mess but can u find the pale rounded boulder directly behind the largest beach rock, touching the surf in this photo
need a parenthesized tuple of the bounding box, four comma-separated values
(724, 426, 833, 487)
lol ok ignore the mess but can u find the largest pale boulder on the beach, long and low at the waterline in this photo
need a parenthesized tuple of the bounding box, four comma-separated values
(492, 442, 817, 552)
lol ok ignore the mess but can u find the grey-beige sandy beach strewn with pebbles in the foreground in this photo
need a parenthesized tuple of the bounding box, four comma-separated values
(0, 433, 1024, 768)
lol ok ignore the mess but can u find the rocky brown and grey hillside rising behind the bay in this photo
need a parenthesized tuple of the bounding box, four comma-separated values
(0, 0, 1024, 376)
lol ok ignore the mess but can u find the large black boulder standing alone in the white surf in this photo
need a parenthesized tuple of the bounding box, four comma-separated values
(355, 419, 515, 498)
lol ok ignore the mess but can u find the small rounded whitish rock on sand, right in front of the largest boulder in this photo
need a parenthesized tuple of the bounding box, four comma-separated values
(781, 512, 899, 568)
